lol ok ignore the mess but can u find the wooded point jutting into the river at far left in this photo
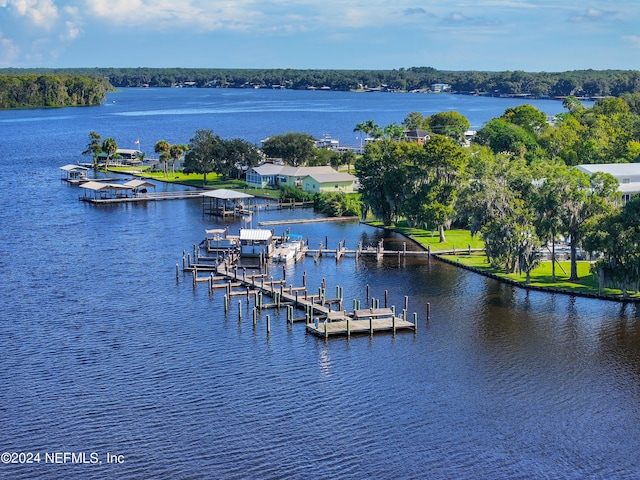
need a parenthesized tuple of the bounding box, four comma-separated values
(0, 73, 113, 109)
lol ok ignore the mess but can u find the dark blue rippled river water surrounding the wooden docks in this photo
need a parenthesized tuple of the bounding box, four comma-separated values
(0, 89, 640, 479)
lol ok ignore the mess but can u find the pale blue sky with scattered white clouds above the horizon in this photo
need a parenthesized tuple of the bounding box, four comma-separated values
(0, 0, 640, 72)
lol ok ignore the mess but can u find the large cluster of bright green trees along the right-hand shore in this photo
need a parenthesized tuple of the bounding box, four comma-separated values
(355, 95, 640, 297)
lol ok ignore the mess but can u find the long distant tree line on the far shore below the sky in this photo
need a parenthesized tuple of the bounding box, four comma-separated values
(0, 67, 640, 97)
